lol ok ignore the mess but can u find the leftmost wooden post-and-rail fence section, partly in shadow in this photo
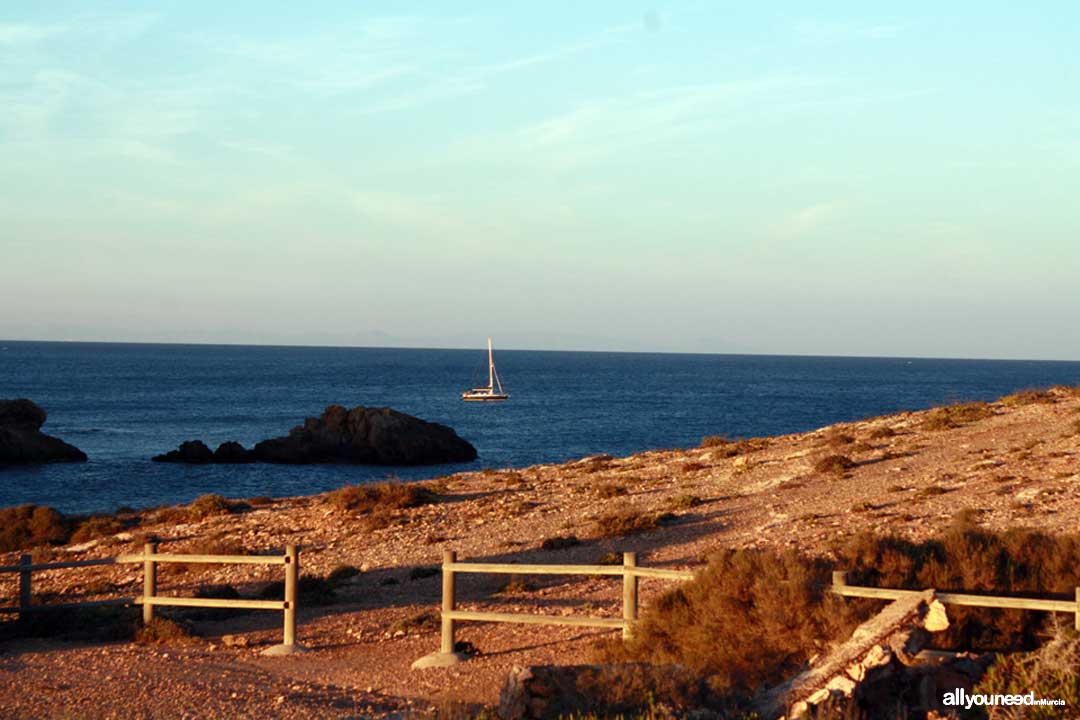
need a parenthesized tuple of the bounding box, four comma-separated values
(0, 543, 302, 655)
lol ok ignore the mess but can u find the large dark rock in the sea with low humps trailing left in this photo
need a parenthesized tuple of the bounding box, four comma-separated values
(153, 405, 476, 465)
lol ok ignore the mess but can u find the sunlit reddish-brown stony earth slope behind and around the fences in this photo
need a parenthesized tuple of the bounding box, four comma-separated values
(0, 390, 1080, 718)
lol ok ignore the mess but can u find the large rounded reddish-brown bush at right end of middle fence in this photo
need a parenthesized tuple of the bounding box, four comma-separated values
(602, 549, 861, 693)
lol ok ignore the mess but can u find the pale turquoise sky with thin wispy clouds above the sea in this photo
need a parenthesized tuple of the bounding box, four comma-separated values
(0, 0, 1080, 359)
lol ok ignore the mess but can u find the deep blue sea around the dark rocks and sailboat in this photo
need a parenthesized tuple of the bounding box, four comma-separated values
(0, 341, 1080, 513)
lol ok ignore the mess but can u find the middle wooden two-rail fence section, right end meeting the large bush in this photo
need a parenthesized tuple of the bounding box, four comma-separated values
(413, 551, 693, 668)
